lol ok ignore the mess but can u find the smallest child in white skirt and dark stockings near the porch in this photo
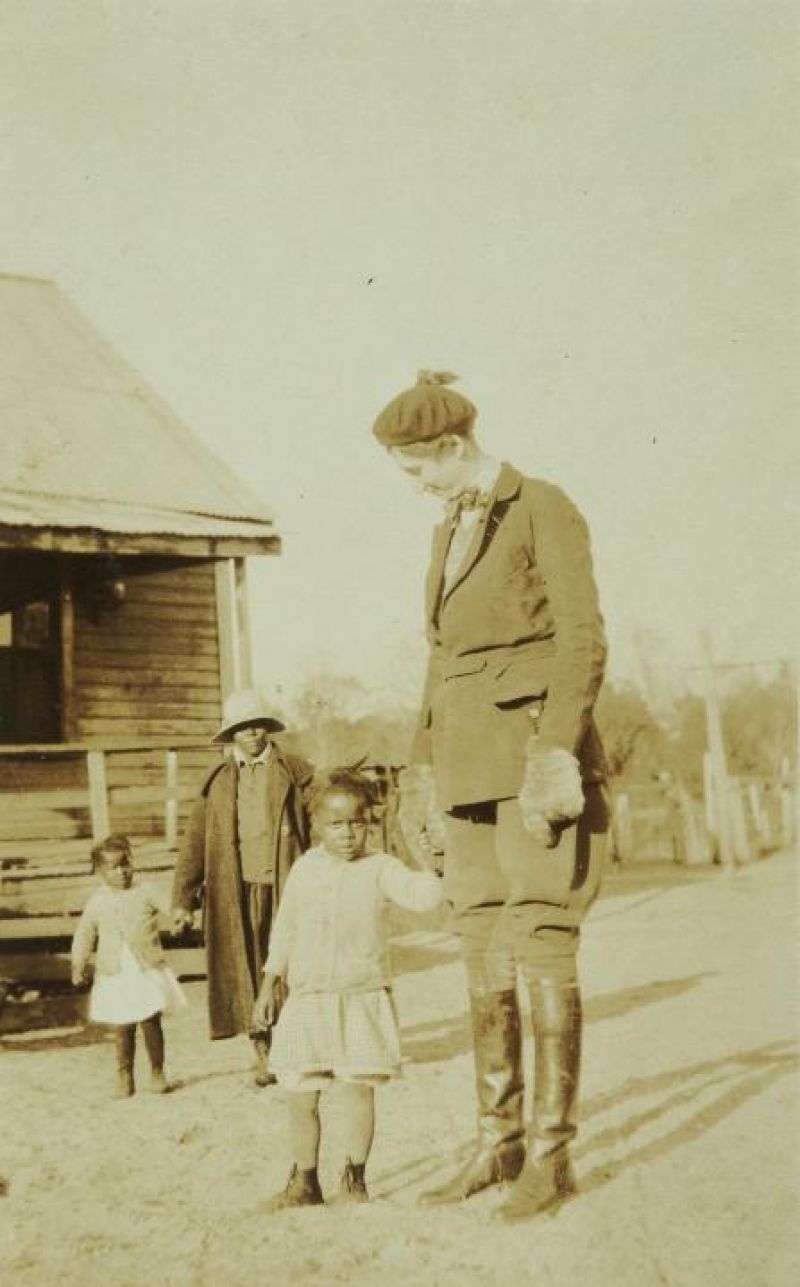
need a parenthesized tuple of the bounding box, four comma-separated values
(72, 835, 186, 1099)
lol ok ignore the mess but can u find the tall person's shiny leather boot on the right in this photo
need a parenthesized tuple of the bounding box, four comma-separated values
(495, 978, 583, 1220)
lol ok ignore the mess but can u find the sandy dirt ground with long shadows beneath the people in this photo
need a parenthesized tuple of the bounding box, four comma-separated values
(0, 855, 800, 1287)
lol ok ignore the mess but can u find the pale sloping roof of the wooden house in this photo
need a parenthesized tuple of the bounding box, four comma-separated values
(0, 274, 275, 543)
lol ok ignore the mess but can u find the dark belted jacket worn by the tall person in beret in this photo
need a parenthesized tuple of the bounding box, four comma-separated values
(410, 465, 606, 808)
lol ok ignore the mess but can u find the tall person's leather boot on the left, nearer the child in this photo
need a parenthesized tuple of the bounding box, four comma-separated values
(419, 988, 525, 1206)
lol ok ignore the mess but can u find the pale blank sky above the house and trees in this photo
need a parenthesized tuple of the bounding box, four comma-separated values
(0, 0, 800, 696)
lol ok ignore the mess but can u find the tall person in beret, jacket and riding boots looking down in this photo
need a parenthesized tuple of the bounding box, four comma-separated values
(373, 372, 610, 1219)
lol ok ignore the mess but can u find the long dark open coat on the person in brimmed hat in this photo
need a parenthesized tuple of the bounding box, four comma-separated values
(172, 744, 313, 1040)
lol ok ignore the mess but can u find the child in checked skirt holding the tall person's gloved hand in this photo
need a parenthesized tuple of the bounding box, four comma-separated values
(253, 770, 441, 1211)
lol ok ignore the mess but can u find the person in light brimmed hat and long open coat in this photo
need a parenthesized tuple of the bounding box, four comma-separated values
(172, 689, 313, 1086)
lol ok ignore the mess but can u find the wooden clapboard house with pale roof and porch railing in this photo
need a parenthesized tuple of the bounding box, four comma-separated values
(0, 275, 279, 938)
